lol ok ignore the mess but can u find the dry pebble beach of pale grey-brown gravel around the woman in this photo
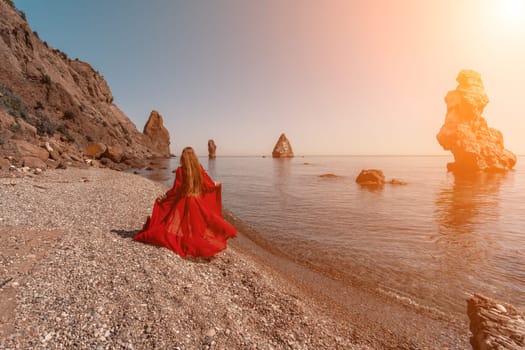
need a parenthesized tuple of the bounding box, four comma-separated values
(0, 168, 368, 349)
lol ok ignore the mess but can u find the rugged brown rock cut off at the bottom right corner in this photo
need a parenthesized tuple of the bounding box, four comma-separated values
(467, 294, 525, 350)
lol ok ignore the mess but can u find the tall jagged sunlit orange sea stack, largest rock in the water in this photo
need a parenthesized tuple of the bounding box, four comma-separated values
(437, 70, 516, 173)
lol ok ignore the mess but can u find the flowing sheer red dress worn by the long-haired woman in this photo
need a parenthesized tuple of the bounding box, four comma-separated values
(133, 166, 237, 257)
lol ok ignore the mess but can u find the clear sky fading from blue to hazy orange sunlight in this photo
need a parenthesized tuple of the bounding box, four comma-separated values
(14, 0, 525, 156)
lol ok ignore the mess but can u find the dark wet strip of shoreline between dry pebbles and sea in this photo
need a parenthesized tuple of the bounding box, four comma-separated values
(225, 210, 470, 349)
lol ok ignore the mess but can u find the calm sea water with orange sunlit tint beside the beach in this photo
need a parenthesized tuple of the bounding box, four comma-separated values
(134, 157, 525, 315)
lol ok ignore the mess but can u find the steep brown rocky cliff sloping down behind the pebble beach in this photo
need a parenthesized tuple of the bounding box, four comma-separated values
(0, 0, 169, 171)
